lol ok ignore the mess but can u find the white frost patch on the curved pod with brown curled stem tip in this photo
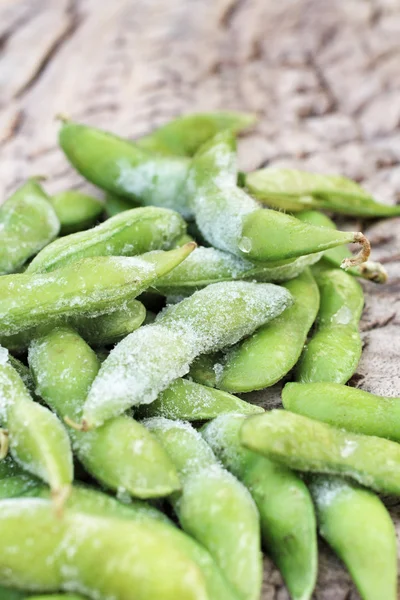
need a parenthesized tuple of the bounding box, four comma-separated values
(193, 185, 260, 256)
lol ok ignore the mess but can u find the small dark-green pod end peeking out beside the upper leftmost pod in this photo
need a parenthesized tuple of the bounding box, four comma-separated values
(50, 190, 104, 235)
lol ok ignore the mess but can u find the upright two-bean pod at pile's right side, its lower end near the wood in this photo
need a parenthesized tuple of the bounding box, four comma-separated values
(296, 268, 364, 383)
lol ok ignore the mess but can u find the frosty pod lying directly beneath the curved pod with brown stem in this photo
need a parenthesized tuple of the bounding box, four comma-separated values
(155, 246, 322, 295)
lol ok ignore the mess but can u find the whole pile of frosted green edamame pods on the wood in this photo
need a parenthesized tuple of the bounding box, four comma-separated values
(0, 112, 400, 600)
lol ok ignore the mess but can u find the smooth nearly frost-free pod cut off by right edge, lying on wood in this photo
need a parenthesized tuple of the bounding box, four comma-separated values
(282, 383, 400, 442)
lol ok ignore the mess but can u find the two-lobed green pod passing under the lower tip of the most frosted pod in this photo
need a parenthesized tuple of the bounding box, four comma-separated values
(28, 327, 180, 498)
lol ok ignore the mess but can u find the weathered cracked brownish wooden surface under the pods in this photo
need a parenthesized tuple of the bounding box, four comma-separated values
(0, 0, 400, 600)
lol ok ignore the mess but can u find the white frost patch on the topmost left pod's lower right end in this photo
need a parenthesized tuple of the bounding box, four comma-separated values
(116, 158, 191, 218)
